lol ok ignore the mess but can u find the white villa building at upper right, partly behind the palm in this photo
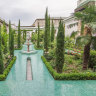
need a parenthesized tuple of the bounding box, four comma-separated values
(64, 0, 96, 36)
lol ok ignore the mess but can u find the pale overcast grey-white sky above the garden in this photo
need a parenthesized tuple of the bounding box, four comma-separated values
(0, 0, 77, 26)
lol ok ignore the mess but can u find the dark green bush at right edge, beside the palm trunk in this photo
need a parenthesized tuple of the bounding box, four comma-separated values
(88, 50, 96, 68)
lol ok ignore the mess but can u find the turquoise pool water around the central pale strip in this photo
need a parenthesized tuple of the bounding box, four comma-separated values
(0, 45, 96, 96)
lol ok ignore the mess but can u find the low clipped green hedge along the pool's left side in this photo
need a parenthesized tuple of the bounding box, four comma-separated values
(0, 57, 16, 81)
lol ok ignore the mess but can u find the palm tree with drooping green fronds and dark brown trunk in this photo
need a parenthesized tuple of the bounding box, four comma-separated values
(75, 6, 96, 70)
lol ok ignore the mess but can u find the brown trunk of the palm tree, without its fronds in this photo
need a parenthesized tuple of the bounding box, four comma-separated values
(83, 27, 92, 70)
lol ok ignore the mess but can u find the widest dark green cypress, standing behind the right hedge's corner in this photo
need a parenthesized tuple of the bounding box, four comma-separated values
(56, 20, 64, 73)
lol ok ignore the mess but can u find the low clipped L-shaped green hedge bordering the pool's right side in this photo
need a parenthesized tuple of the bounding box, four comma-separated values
(41, 56, 96, 80)
